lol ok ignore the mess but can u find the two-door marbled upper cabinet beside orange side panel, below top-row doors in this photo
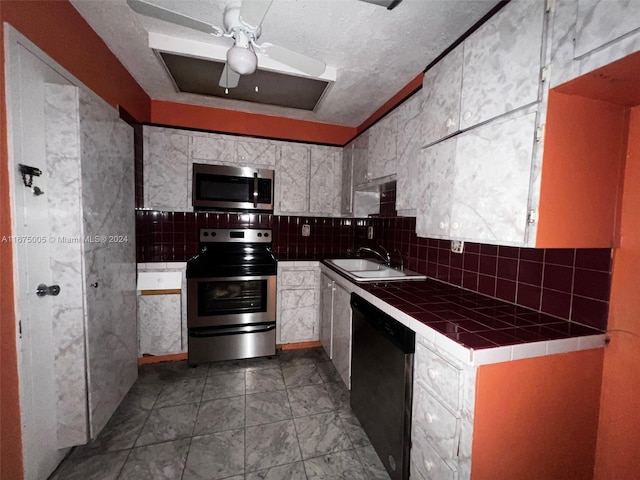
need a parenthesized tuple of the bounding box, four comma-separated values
(416, 111, 536, 245)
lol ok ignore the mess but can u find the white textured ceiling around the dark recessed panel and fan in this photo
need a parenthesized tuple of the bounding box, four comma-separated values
(71, 0, 497, 127)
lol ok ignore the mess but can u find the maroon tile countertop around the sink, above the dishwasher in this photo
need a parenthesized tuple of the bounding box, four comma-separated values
(323, 262, 603, 350)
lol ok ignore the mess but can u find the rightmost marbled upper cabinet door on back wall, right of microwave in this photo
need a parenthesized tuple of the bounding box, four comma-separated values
(309, 145, 342, 215)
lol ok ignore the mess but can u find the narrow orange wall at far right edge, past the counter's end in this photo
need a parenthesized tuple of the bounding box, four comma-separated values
(595, 106, 640, 480)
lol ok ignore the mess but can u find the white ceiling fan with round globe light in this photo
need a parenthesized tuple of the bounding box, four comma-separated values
(127, 0, 326, 88)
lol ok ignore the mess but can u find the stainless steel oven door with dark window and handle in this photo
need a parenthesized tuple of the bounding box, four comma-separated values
(187, 275, 276, 328)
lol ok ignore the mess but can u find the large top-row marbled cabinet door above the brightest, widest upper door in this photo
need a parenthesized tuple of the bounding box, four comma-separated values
(460, 0, 545, 129)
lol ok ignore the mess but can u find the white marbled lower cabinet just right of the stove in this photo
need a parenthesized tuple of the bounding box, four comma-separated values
(276, 262, 320, 344)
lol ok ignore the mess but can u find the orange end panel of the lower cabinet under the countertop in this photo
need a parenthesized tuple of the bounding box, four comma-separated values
(471, 349, 604, 480)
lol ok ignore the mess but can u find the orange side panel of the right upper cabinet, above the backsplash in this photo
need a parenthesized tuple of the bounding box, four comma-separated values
(536, 91, 628, 248)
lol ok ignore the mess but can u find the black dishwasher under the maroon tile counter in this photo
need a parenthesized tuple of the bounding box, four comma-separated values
(351, 293, 415, 480)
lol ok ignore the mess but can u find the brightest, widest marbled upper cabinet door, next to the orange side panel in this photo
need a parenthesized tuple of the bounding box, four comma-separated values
(450, 112, 536, 244)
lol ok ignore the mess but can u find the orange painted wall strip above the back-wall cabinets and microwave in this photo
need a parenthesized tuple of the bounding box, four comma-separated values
(151, 100, 356, 146)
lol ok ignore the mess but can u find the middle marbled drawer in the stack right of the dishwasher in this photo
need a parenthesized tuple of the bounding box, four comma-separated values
(411, 384, 460, 459)
